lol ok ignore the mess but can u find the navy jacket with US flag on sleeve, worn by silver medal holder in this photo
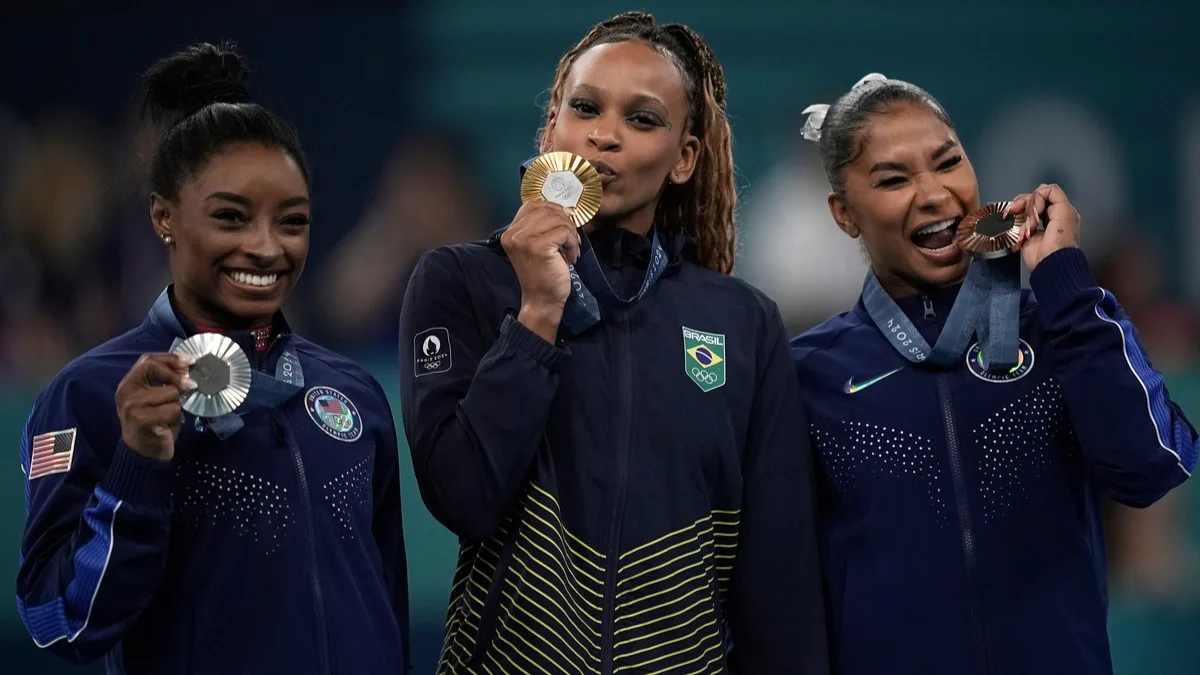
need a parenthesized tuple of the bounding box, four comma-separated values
(17, 292, 408, 675)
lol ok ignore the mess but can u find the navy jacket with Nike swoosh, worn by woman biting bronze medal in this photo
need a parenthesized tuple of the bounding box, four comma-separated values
(792, 249, 1196, 675)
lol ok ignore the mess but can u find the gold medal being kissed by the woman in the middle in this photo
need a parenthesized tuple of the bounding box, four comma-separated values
(521, 153, 604, 227)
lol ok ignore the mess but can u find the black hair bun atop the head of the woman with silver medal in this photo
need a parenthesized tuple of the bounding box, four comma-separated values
(140, 42, 250, 121)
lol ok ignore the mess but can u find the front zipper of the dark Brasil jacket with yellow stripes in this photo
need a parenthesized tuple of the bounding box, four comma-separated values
(600, 312, 634, 675)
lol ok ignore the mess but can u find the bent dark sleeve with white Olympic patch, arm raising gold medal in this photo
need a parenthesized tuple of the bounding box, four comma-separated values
(400, 247, 568, 540)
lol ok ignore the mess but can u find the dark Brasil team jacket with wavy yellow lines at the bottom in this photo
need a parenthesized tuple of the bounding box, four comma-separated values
(401, 225, 827, 675)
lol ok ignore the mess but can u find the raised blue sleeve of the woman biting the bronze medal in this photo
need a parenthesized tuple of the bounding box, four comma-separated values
(1030, 249, 1196, 507)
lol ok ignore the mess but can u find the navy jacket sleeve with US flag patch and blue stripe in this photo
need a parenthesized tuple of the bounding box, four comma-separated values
(17, 376, 174, 663)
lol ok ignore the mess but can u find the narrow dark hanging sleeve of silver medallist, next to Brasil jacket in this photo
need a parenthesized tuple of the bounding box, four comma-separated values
(371, 383, 413, 673)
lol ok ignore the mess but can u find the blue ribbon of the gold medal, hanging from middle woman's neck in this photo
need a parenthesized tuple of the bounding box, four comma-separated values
(521, 157, 667, 335)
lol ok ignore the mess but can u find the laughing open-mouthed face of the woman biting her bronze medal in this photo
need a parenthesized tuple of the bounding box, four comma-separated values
(829, 102, 979, 297)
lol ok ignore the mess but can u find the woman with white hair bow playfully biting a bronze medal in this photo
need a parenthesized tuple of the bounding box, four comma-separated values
(792, 73, 1198, 675)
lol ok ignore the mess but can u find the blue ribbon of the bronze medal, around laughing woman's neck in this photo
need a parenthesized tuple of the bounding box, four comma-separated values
(863, 255, 1021, 371)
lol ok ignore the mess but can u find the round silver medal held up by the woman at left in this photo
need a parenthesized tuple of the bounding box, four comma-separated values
(174, 333, 251, 419)
